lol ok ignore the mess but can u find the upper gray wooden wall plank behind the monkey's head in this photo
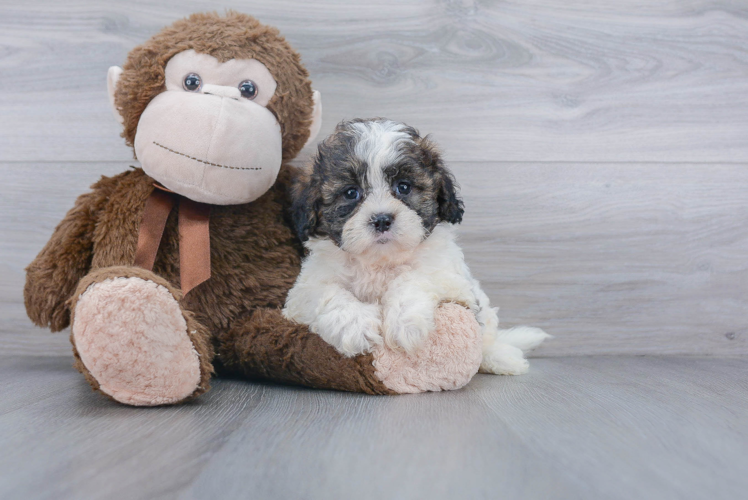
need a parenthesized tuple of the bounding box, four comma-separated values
(0, 0, 748, 162)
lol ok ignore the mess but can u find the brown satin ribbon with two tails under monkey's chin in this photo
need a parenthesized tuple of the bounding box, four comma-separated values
(134, 184, 210, 295)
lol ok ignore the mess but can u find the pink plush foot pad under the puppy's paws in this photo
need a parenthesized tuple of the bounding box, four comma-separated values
(372, 304, 483, 393)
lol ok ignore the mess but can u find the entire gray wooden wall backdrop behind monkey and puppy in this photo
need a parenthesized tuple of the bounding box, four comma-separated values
(0, 0, 748, 356)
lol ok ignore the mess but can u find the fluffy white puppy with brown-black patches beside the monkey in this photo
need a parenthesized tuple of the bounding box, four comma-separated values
(283, 118, 548, 374)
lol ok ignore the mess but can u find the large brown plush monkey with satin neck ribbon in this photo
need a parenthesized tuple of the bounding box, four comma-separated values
(24, 12, 488, 405)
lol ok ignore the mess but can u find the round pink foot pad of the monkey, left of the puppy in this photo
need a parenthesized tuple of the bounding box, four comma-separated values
(73, 277, 200, 406)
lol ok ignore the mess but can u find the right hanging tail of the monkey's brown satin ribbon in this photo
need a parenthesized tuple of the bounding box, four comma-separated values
(179, 198, 210, 295)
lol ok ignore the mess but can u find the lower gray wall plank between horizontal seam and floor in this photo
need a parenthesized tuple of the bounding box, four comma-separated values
(0, 162, 748, 356)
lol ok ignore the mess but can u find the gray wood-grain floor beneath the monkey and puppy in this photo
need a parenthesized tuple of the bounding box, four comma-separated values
(0, 357, 748, 500)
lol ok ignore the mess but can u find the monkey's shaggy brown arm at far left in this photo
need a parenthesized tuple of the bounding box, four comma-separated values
(23, 183, 108, 332)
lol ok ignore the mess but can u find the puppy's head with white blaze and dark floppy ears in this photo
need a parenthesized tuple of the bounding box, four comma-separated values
(293, 119, 463, 254)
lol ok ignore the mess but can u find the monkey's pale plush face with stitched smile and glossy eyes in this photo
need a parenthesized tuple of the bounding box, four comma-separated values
(134, 50, 283, 205)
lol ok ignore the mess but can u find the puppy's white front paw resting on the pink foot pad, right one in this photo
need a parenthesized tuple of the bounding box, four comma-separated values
(382, 300, 436, 353)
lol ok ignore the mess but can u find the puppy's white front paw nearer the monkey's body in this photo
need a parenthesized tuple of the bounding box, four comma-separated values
(312, 304, 382, 357)
